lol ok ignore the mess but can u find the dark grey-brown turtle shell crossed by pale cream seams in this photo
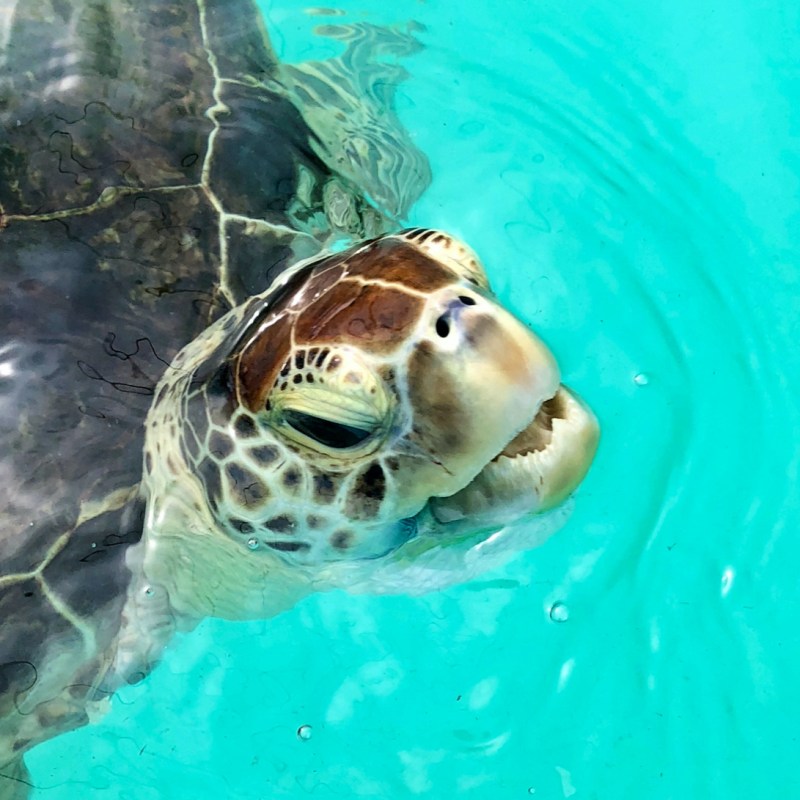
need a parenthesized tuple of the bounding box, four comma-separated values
(0, 0, 424, 764)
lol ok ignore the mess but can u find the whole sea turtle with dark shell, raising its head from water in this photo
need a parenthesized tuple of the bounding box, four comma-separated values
(0, 0, 597, 800)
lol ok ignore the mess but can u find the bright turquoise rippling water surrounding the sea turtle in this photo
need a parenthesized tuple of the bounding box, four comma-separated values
(29, 0, 800, 800)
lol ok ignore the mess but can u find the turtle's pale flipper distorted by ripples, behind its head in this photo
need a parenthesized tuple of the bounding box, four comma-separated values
(282, 23, 431, 219)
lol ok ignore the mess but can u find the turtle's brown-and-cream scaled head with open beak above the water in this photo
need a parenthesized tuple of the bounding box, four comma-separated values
(144, 229, 597, 620)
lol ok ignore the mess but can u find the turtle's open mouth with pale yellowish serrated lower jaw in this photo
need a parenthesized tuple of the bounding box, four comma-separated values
(430, 384, 599, 527)
